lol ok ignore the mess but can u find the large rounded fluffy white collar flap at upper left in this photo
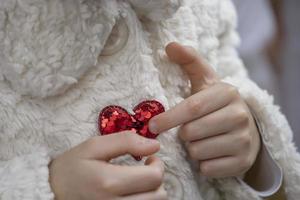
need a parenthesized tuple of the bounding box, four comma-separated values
(0, 0, 118, 97)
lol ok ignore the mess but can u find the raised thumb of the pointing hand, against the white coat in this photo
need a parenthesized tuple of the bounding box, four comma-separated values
(166, 42, 218, 94)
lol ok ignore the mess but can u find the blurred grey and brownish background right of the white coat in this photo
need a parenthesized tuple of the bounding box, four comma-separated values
(233, 0, 300, 151)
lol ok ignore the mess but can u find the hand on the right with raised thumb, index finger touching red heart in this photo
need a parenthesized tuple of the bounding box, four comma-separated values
(149, 43, 260, 178)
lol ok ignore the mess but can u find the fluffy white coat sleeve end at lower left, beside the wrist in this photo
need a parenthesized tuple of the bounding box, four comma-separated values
(0, 150, 54, 200)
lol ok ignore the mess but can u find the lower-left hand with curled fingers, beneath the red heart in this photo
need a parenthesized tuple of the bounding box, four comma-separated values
(49, 132, 167, 200)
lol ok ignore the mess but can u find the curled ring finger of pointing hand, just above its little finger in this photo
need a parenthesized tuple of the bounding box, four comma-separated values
(187, 132, 241, 161)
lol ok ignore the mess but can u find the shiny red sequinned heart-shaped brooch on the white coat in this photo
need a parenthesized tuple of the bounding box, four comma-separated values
(98, 100, 165, 160)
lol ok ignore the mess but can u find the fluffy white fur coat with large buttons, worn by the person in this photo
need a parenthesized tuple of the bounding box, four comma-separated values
(0, 0, 300, 200)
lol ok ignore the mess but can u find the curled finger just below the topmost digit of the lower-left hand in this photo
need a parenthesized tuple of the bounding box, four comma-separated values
(101, 157, 164, 196)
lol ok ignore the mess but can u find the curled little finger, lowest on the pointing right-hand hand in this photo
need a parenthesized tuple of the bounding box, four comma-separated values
(200, 157, 249, 178)
